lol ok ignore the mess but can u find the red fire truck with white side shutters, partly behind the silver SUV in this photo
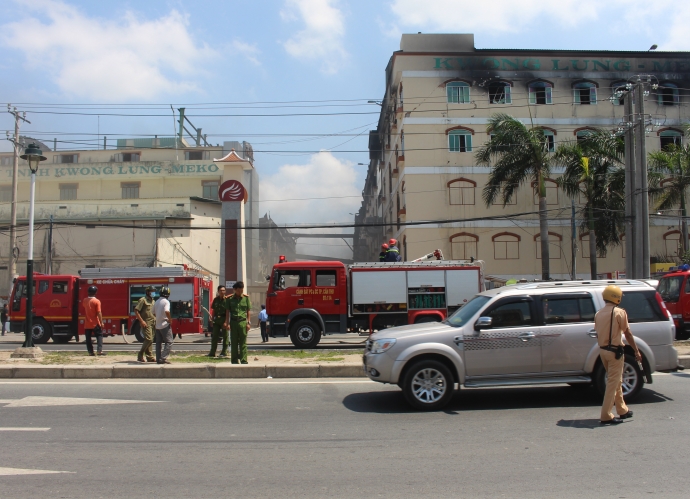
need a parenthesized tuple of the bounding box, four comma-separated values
(266, 261, 484, 348)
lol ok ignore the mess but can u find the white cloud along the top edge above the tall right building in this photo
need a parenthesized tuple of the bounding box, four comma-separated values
(391, 0, 618, 33)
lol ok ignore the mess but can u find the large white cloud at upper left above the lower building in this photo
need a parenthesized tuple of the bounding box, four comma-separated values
(0, 0, 215, 101)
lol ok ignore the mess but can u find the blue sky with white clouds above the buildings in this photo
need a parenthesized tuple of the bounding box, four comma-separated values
(0, 0, 690, 257)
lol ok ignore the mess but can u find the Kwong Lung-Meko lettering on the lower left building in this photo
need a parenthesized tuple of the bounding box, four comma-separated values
(3, 162, 220, 178)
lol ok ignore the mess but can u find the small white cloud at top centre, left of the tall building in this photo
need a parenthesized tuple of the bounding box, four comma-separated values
(281, 0, 348, 74)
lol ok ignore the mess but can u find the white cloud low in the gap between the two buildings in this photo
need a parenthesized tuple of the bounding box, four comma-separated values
(260, 151, 362, 258)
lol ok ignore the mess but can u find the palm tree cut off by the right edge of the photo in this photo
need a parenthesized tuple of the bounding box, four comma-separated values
(648, 144, 690, 254)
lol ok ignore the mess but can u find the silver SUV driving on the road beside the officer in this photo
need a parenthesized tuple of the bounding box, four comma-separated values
(363, 280, 678, 410)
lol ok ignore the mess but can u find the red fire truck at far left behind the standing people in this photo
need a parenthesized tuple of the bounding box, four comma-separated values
(10, 267, 212, 343)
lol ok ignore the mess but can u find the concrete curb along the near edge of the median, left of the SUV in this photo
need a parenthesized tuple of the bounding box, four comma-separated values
(0, 366, 366, 379)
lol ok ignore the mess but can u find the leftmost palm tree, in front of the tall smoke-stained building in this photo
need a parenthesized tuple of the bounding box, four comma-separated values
(476, 114, 552, 281)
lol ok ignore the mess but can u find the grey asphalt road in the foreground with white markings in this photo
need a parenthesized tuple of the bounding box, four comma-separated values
(0, 373, 690, 499)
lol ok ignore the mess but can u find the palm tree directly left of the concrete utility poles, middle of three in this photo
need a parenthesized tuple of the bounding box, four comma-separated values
(554, 130, 625, 279)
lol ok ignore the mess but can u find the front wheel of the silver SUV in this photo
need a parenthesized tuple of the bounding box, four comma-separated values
(402, 360, 455, 411)
